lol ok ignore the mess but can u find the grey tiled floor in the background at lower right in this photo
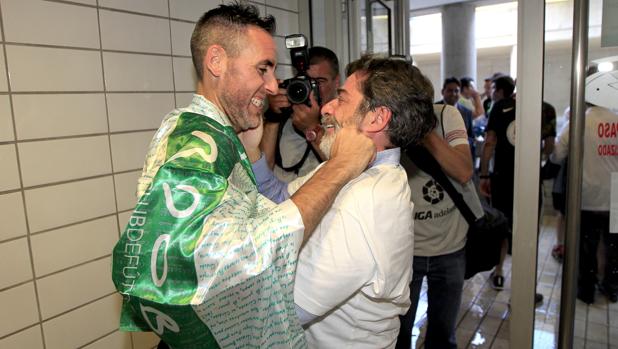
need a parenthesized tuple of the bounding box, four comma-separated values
(412, 215, 618, 349)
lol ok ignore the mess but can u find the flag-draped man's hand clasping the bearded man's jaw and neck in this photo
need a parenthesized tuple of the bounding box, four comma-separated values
(329, 124, 376, 178)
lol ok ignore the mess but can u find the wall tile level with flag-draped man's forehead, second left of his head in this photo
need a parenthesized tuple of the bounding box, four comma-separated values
(100, 9, 171, 54)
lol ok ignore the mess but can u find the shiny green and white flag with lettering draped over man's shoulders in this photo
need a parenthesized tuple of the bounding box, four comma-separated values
(112, 112, 306, 348)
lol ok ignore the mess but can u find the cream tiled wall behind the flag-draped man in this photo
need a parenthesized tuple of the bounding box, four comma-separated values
(0, 0, 299, 349)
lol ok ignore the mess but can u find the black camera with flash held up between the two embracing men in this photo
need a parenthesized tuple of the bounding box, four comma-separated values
(279, 34, 322, 107)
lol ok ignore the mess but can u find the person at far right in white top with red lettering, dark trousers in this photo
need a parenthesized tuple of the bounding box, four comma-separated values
(550, 103, 618, 304)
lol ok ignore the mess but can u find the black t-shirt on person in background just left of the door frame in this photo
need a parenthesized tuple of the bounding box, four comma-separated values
(486, 98, 515, 177)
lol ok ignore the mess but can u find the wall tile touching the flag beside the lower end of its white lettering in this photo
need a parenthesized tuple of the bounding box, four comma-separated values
(36, 257, 117, 318)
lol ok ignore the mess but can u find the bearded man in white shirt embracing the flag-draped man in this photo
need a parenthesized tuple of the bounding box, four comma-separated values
(245, 56, 436, 348)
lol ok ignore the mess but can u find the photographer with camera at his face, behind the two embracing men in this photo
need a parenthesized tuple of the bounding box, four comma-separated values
(261, 46, 339, 181)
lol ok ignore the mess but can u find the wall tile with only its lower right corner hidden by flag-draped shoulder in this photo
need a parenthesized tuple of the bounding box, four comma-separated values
(107, 93, 174, 132)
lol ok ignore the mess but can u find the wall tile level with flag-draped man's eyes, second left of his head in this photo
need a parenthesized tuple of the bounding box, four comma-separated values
(103, 52, 173, 91)
